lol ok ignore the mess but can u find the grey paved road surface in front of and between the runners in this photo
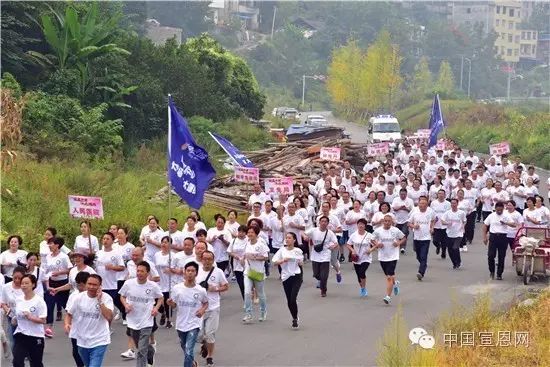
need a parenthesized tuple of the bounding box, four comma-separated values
(41, 115, 547, 367)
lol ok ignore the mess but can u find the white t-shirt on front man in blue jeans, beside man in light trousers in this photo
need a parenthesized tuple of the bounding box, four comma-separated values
(171, 283, 208, 332)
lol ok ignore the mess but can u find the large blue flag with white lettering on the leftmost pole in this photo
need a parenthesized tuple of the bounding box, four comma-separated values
(168, 97, 216, 209)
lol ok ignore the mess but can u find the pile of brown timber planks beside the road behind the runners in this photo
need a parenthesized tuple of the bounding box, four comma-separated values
(205, 138, 366, 210)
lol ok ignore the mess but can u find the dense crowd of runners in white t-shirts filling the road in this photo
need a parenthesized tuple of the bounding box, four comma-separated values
(0, 140, 550, 367)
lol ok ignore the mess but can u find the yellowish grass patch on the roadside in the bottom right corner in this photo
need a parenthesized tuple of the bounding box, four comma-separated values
(377, 290, 550, 367)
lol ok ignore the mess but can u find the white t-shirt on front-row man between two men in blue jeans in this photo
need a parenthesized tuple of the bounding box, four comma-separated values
(118, 278, 162, 330)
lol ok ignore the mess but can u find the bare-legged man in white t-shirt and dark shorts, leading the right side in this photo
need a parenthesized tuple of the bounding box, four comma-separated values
(371, 215, 407, 305)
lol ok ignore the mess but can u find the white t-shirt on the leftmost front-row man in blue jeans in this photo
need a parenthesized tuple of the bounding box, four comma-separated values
(67, 292, 114, 348)
